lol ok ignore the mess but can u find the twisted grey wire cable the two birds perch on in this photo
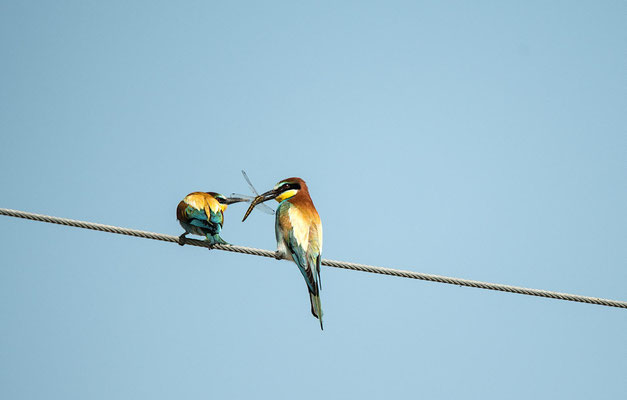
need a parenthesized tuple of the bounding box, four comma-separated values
(0, 208, 627, 308)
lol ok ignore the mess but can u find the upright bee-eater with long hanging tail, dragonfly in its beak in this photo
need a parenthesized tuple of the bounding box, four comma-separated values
(242, 178, 323, 329)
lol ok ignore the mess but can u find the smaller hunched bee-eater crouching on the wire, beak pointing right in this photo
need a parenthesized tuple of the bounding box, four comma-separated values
(176, 192, 245, 246)
